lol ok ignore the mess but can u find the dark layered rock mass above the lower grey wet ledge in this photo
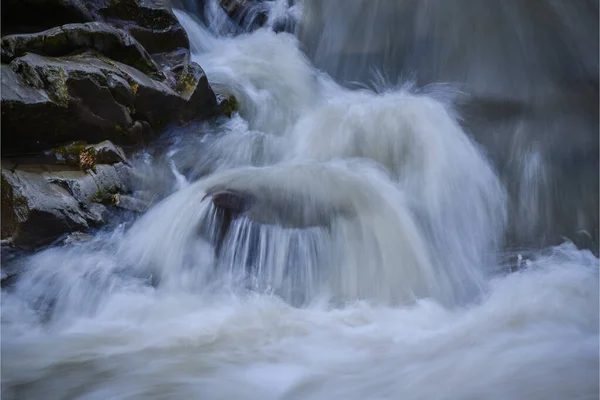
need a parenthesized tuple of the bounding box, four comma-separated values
(1, 0, 218, 155)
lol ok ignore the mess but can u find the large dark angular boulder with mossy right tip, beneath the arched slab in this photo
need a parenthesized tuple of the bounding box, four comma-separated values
(1, 53, 216, 154)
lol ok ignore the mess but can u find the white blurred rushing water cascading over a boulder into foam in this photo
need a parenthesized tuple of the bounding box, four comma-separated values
(2, 0, 600, 400)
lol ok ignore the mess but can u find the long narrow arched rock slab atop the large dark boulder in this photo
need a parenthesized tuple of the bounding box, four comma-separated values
(2, 22, 160, 77)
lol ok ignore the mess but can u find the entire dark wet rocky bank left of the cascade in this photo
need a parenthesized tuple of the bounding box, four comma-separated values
(0, 0, 223, 250)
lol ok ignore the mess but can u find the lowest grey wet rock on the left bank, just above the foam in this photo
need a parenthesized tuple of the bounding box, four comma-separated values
(1, 163, 131, 250)
